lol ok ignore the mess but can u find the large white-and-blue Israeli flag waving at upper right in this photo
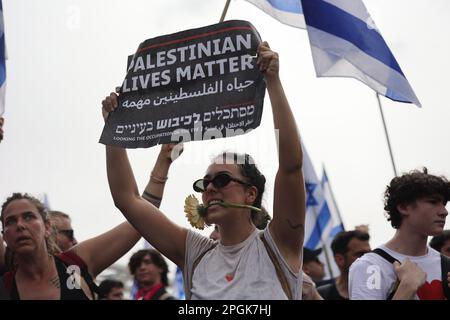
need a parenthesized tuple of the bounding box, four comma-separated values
(302, 0, 421, 107)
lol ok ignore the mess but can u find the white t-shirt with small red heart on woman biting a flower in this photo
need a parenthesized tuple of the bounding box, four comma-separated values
(183, 227, 302, 300)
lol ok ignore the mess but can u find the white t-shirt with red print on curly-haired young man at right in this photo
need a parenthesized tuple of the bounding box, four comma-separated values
(348, 246, 445, 300)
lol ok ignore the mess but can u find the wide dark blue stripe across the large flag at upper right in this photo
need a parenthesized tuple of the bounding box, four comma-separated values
(302, 0, 404, 76)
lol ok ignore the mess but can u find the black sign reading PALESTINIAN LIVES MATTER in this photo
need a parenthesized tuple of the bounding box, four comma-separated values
(100, 20, 265, 148)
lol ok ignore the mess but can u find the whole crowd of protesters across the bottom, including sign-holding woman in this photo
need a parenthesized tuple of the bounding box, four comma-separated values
(0, 42, 450, 300)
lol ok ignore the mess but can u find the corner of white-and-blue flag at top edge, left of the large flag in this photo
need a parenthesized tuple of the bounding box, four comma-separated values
(243, 0, 306, 29)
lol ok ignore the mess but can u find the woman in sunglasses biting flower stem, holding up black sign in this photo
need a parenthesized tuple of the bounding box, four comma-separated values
(103, 42, 305, 299)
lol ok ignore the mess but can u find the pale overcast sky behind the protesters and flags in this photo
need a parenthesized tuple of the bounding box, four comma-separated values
(0, 0, 450, 263)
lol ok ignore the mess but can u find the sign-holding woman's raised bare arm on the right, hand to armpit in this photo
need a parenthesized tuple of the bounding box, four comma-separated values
(258, 42, 305, 271)
